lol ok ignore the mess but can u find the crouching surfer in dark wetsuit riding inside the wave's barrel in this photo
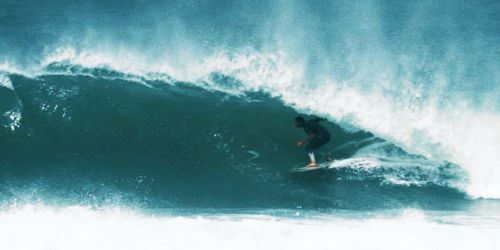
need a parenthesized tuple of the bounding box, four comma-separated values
(295, 116, 332, 167)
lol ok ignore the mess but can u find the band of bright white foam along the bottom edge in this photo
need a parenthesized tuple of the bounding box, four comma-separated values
(0, 206, 500, 250)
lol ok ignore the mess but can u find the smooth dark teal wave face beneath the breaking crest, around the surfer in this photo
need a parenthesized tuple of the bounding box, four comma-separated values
(0, 72, 465, 210)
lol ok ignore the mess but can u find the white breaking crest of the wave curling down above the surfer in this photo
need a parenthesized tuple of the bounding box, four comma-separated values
(2, 47, 496, 200)
